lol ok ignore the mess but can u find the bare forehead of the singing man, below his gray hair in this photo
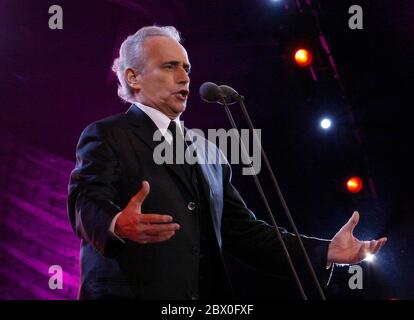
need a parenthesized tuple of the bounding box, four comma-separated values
(143, 36, 189, 63)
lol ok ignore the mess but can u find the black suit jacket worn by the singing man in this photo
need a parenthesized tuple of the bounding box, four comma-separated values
(68, 106, 329, 299)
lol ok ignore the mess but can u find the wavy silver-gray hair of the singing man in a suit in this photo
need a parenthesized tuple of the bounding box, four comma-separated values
(112, 26, 181, 103)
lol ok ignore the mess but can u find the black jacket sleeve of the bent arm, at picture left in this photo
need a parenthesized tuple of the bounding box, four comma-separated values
(68, 124, 123, 256)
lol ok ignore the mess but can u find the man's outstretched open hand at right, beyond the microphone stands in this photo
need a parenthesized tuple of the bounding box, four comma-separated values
(328, 211, 387, 265)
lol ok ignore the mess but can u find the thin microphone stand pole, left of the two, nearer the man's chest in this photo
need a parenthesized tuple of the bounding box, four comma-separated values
(220, 94, 308, 300)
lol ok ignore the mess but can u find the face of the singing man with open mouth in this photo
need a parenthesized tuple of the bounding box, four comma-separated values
(136, 36, 190, 119)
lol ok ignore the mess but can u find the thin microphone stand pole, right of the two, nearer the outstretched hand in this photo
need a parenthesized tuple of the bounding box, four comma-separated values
(231, 94, 326, 300)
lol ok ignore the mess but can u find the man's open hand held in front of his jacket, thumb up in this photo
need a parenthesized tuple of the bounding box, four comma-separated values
(115, 181, 180, 244)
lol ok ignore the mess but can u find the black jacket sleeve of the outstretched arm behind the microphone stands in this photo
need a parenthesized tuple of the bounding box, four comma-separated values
(222, 164, 332, 286)
